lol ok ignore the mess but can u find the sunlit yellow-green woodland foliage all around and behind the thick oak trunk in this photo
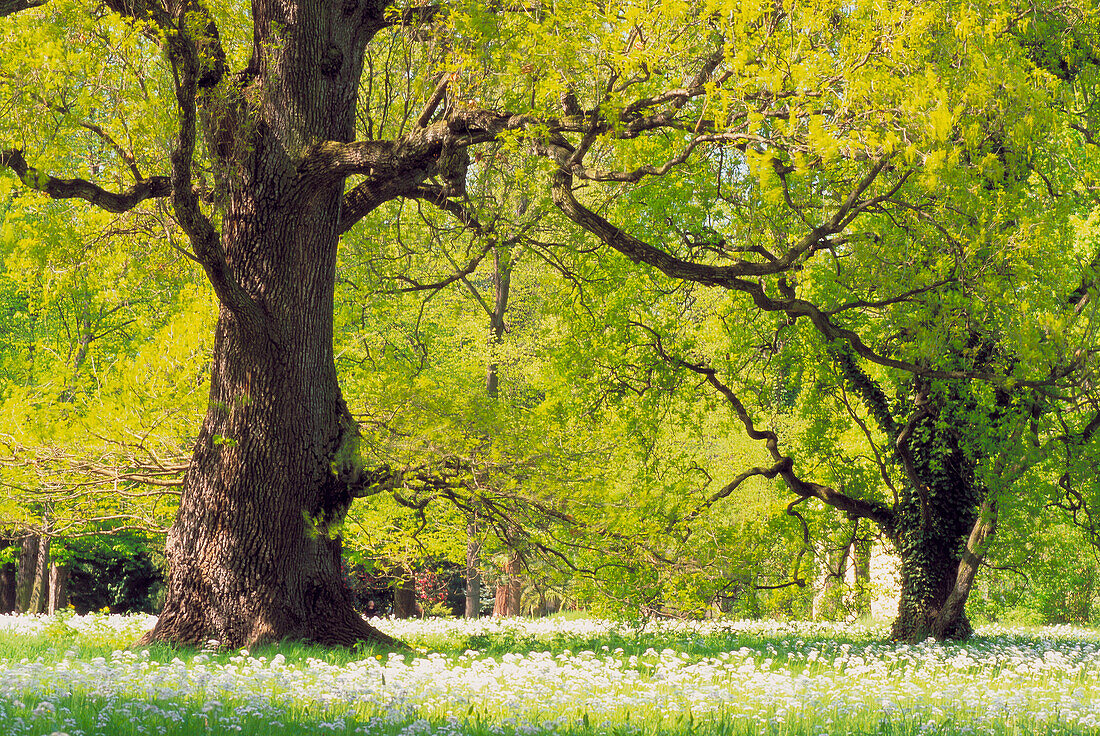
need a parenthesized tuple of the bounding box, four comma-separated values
(0, 2, 1100, 638)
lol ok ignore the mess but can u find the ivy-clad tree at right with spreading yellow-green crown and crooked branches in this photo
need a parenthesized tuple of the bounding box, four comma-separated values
(510, 4, 1096, 640)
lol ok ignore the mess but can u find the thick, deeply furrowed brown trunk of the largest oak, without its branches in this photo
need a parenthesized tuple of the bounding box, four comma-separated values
(134, 0, 399, 647)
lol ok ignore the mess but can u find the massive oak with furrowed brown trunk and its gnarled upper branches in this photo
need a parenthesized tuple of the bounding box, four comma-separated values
(0, 0, 517, 646)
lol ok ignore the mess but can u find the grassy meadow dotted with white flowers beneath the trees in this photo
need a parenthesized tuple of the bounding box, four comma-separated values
(0, 614, 1100, 736)
